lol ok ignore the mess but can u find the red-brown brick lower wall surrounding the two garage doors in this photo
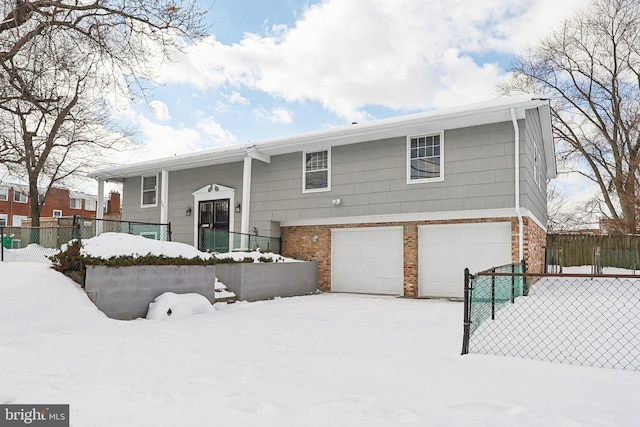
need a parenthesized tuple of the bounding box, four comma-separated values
(282, 218, 546, 297)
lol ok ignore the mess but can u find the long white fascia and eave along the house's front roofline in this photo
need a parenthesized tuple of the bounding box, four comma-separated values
(88, 95, 548, 181)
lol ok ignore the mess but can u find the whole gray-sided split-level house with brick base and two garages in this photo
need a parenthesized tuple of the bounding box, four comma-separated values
(91, 95, 556, 297)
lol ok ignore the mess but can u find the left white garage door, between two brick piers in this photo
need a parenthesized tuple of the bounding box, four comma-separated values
(331, 227, 404, 295)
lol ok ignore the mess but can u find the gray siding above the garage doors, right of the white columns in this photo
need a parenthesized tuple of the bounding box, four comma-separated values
(251, 122, 515, 222)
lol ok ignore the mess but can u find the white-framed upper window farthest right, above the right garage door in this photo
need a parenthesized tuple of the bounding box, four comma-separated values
(407, 132, 444, 184)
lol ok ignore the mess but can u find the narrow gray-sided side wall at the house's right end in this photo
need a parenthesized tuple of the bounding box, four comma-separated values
(520, 109, 547, 225)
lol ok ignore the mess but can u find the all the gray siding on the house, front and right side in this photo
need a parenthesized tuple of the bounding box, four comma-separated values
(123, 115, 546, 244)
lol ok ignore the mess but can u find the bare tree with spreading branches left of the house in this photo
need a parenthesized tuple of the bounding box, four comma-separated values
(0, 0, 205, 225)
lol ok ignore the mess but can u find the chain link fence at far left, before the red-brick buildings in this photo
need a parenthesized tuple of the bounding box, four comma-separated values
(0, 216, 171, 263)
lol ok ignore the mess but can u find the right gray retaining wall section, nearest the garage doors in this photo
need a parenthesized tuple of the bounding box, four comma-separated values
(216, 261, 318, 301)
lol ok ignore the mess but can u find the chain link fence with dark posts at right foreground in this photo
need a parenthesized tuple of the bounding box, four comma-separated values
(462, 266, 640, 371)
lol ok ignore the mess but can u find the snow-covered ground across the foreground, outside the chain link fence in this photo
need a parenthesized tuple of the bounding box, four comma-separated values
(0, 263, 640, 427)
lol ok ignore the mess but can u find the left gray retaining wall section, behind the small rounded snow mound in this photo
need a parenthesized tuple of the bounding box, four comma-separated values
(85, 265, 216, 320)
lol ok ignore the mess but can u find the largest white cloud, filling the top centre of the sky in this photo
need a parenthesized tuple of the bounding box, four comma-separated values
(155, 0, 586, 120)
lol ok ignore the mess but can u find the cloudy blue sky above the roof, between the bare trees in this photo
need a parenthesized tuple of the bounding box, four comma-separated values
(117, 0, 587, 161)
